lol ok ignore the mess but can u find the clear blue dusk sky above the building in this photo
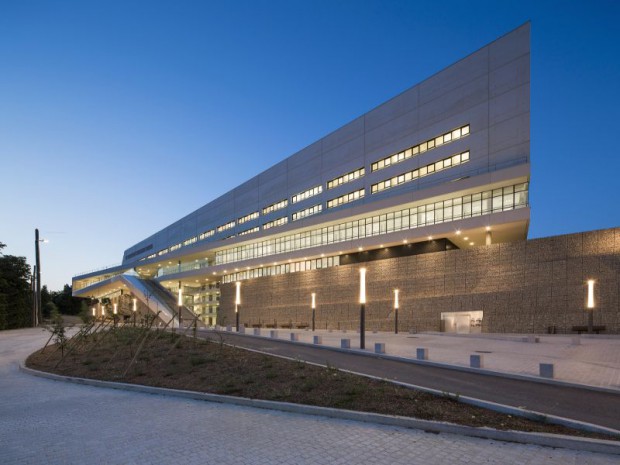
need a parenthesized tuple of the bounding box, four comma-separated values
(0, 0, 620, 290)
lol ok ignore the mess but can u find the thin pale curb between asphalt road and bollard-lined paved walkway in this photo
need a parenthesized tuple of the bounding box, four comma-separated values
(208, 329, 620, 394)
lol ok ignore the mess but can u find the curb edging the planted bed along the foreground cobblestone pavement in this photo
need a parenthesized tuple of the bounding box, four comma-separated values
(19, 363, 620, 455)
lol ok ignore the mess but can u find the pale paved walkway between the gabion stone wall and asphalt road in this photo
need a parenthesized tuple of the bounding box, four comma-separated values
(226, 328, 620, 392)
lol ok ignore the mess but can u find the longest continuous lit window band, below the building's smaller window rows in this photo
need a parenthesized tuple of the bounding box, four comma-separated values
(215, 183, 528, 265)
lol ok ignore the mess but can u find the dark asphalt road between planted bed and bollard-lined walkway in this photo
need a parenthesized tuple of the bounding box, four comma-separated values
(203, 333, 620, 430)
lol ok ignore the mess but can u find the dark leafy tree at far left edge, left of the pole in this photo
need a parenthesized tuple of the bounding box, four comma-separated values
(0, 242, 32, 329)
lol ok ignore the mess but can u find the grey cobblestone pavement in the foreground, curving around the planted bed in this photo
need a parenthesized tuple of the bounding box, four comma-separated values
(0, 329, 618, 465)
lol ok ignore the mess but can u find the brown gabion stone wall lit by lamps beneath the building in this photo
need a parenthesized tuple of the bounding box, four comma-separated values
(218, 228, 620, 334)
